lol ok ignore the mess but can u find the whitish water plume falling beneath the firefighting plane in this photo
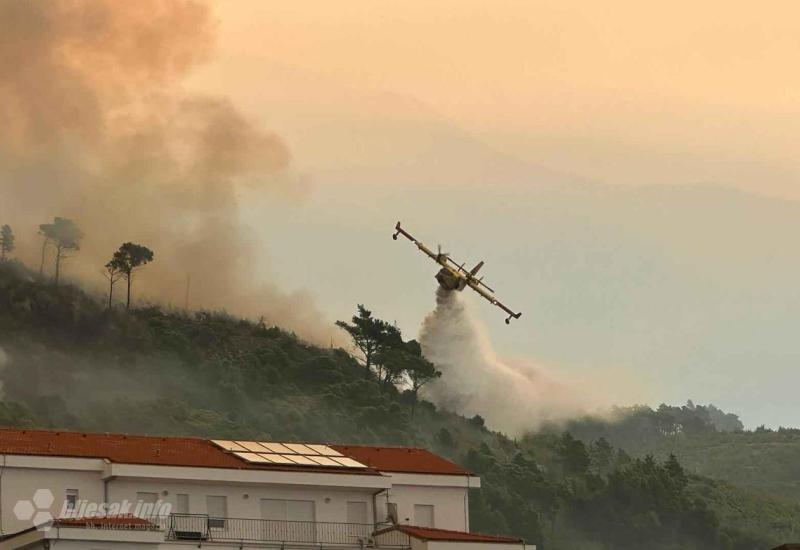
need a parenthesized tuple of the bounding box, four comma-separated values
(420, 288, 594, 435)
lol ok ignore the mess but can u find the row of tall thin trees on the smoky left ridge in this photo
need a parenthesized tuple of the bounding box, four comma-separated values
(0, 217, 153, 309)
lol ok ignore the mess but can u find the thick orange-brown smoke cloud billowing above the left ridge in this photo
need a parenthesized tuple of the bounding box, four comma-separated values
(0, 0, 331, 343)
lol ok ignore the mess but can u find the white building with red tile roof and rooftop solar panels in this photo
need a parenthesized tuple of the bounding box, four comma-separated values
(0, 429, 524, 550)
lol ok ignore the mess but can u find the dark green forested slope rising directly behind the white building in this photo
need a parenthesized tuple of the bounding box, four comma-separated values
(0, 261, 800, 550)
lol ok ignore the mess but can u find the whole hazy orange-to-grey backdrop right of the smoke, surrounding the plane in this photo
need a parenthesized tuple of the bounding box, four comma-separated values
(186, 0, 800, 426)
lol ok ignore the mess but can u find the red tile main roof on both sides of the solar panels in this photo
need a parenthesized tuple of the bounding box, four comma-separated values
(0, 428, 469, 475)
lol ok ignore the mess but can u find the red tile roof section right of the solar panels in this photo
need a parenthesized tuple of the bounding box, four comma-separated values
(331, 445, 471, 476)
